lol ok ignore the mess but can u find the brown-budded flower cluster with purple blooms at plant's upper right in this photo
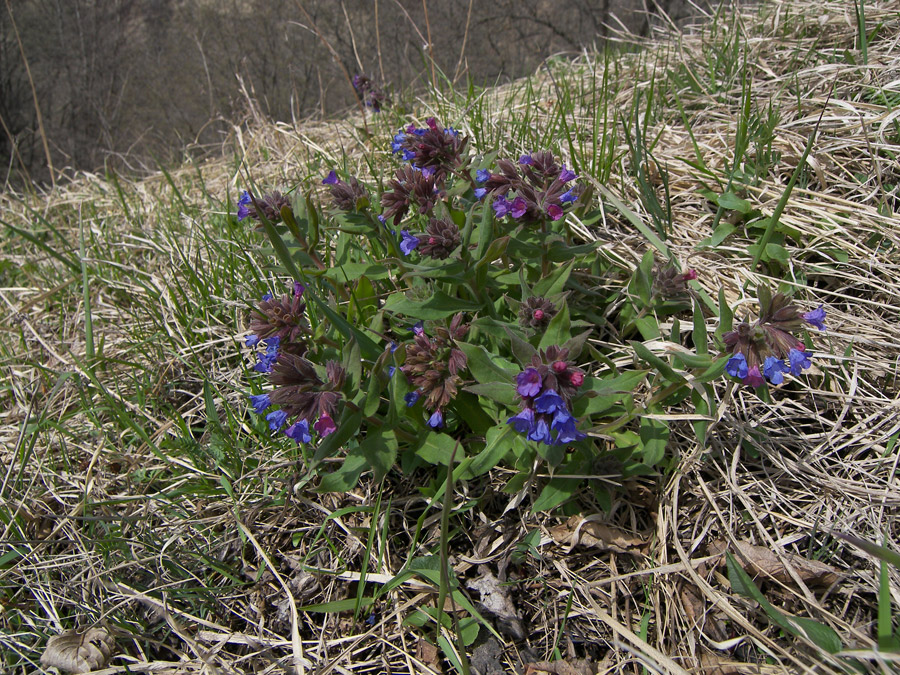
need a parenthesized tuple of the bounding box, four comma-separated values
(478, 150, 579, 223)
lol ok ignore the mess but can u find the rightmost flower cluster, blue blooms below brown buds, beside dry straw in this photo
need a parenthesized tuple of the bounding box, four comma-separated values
(722, 286, 825, 387)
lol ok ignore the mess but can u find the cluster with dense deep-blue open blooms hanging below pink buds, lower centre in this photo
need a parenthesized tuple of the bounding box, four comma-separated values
(506, 347, 586, 445)
